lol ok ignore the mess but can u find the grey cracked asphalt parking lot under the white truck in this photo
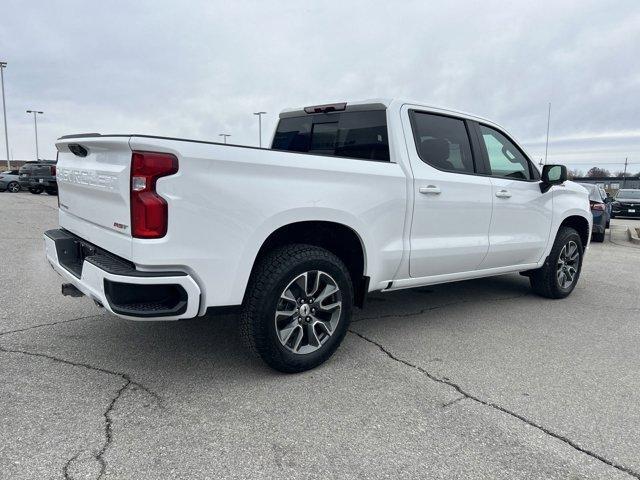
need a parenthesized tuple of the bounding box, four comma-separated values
(0, 193, 640, 479)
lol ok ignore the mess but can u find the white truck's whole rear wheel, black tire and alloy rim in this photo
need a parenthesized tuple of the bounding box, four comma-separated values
(240, 244, 353, 373)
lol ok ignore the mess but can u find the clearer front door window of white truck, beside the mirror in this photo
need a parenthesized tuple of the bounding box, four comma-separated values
(480, 125, 531, 180)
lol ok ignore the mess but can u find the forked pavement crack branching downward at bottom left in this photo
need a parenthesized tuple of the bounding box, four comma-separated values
(0, 344, 163, 480)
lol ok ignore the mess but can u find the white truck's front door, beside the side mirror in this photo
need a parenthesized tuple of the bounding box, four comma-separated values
(474, 122, 553, 269)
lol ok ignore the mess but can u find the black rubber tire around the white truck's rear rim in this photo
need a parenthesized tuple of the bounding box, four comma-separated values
(240, 244, 353, 373)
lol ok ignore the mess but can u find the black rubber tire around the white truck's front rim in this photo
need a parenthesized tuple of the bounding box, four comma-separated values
(529, 227, 584, 298)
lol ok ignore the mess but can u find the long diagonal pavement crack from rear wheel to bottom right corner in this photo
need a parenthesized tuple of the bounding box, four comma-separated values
(349, 329, 640, 479)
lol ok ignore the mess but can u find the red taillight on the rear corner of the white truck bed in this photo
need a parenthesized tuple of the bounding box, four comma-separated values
(131, 152, 178, 238)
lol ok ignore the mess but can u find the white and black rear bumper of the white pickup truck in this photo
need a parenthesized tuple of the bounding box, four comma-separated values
(44, 230, 200, 320)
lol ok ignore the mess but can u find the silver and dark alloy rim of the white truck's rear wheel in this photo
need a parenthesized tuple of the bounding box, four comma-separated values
(274, 270, 342, 354)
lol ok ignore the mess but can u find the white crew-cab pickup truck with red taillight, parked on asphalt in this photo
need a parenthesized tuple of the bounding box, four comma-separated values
(44, 100, 592, 372)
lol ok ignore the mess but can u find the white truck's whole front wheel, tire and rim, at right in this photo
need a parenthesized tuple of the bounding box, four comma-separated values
(529, 227, 583, 298)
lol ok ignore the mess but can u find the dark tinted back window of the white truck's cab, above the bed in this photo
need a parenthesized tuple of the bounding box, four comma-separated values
(271, 110, 389, 161)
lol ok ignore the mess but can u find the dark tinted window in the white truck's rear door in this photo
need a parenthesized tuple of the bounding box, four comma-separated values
(411, 112, 475, 173)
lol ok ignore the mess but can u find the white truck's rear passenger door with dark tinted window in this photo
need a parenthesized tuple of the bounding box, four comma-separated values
(403, 107, 492, 278)
